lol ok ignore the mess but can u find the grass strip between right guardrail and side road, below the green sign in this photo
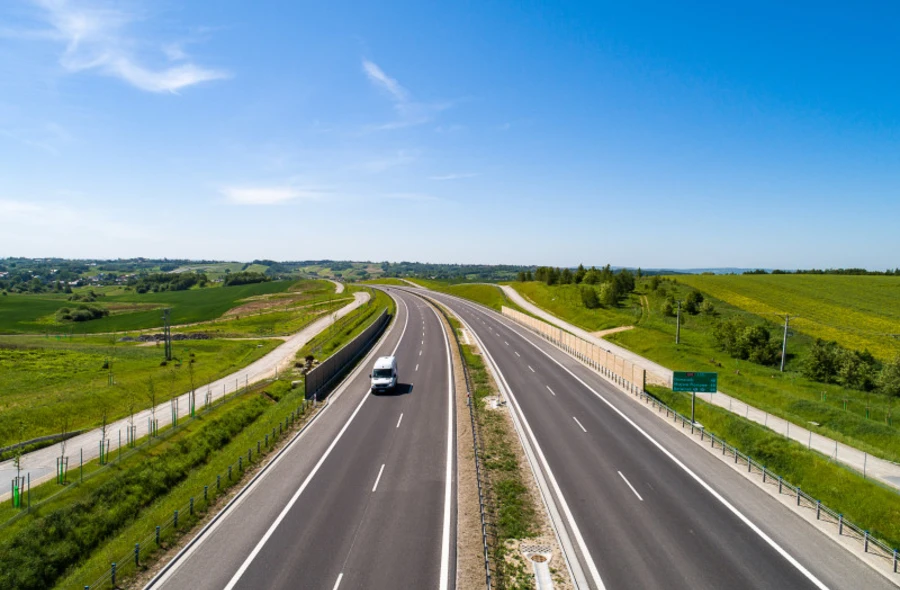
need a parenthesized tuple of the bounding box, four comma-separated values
(648, 387, 900, 547)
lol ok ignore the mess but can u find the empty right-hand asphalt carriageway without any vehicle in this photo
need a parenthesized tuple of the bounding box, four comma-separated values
(413, 290, 894, 590)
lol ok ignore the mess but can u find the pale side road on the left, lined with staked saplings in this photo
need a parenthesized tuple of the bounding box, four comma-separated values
(0, 292, 370, 501)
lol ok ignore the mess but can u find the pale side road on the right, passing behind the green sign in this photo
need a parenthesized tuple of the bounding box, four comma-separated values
(500, 285, 900, 488)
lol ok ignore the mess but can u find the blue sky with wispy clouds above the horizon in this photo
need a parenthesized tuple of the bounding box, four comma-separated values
(0, 0, 900, 269)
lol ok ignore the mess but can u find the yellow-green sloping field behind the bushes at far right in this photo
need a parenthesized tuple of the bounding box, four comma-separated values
(677, 275, 900, 360)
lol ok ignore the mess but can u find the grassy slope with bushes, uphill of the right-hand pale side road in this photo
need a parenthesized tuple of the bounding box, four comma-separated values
(513, 277, 900, 468)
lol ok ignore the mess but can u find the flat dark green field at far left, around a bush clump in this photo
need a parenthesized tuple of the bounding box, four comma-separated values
(0, 281, 334, 334)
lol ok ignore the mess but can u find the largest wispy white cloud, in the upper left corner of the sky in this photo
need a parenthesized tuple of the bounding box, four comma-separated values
(20, 0, 231, 93)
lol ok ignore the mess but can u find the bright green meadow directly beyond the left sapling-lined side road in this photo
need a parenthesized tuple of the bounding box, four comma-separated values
(0, 336, 279, 447)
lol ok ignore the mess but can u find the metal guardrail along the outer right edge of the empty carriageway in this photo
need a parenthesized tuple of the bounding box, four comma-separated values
(507, 308, 898, 574)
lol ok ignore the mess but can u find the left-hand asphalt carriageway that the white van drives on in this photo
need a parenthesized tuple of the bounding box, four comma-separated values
(148, 290, 456, 590)
